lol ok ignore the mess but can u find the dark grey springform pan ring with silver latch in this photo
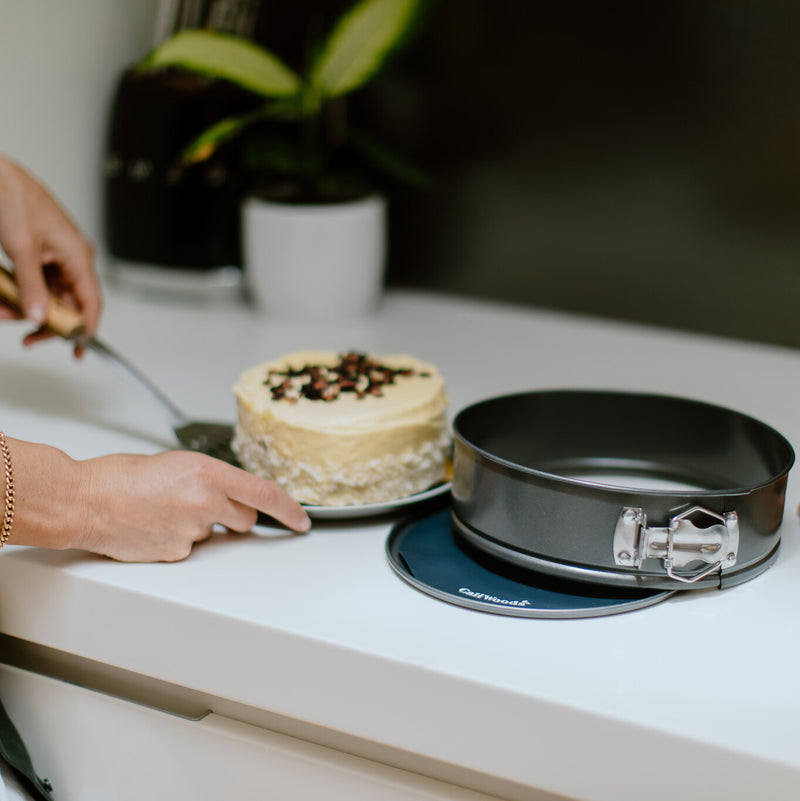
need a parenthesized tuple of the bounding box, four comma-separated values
(452, 390, 794, 589)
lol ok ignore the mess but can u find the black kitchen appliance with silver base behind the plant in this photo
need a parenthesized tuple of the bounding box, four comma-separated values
(104, 0, 258, 297)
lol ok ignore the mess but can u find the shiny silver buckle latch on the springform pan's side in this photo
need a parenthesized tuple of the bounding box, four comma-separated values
(613, 506, 739, 584)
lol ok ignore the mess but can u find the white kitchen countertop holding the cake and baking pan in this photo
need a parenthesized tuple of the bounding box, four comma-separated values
(0, 292, 800, 801)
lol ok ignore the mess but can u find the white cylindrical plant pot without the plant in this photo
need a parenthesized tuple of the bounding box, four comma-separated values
(242, 195, 386, 320)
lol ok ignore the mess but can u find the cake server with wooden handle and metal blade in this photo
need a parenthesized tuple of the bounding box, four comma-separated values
(0, 268, 238, 464)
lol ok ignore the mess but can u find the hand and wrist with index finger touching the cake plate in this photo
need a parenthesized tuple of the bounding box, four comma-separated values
(8, 438, 310, 562)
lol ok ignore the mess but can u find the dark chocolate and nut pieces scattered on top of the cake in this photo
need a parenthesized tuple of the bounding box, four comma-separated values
(264, 351, 430, 403)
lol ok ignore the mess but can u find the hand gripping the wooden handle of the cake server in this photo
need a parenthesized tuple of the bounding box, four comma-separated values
(0, 156, 102, 355)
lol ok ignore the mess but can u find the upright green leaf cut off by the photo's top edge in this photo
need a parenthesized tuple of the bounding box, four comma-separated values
(309, 0, 422, 97)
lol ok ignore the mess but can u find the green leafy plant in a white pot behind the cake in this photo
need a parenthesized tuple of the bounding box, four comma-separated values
(142, 0, 432, 319)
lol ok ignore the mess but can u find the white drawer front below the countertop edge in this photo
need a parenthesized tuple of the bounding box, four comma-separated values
(0, 665, 510, 801)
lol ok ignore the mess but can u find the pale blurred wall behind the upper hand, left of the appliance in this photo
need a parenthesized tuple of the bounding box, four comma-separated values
(0, 0, 158, 267)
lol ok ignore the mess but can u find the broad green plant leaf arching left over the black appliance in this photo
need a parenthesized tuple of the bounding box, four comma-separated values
(141, 30, 302, 97)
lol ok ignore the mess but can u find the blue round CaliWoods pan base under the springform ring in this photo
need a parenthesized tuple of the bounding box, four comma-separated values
(386, 506, 675, 618)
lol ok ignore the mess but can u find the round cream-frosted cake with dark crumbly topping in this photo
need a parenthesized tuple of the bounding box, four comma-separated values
(232, 351, 450, 506)
